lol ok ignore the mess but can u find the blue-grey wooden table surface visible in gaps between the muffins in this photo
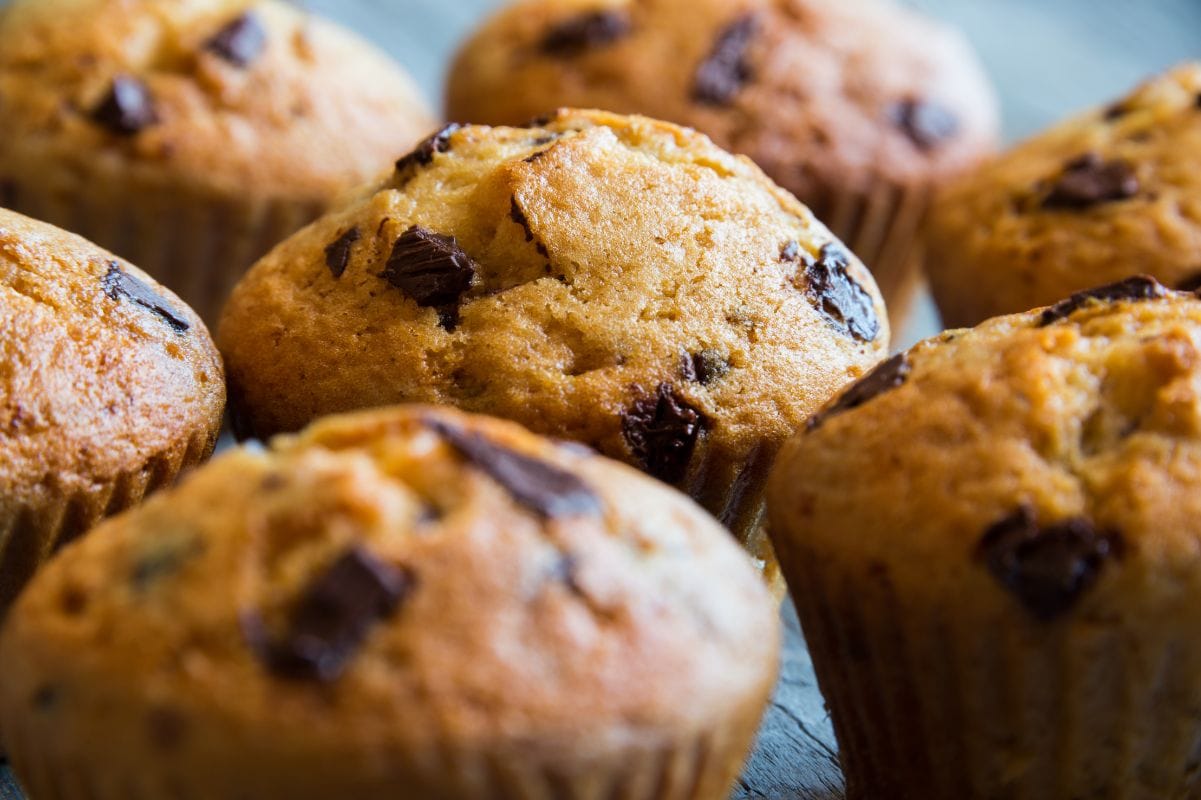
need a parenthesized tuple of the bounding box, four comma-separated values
(0, 0, 1201, 800)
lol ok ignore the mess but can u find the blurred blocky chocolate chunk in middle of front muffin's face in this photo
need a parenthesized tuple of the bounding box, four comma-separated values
(243, 545, 416, 682)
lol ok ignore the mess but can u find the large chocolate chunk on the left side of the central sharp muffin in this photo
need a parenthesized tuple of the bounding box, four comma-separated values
(380, 225, 477, 308)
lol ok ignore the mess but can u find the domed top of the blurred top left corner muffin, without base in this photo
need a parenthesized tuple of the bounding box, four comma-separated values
(0, 0, 434, 201)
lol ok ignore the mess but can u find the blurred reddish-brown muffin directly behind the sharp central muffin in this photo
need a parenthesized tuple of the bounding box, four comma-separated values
(447, 0, 998, 327)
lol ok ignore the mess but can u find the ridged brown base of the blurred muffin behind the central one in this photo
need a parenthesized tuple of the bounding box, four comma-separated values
(809, 184, 934, 330)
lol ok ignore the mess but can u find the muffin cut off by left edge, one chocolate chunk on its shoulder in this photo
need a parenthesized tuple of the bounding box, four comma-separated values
(0, 209, 225, 612)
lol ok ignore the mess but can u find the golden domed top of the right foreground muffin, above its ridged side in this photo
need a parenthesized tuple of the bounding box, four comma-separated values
(769, 277, 1201, 625)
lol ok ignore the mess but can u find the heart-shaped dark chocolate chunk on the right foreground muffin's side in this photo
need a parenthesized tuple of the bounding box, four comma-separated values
(978, 506, 1123, 622)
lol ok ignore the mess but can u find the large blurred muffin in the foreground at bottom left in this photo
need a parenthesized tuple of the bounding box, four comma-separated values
(0, 407, 779, 800)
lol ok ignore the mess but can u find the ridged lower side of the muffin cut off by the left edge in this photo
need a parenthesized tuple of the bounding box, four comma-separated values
(0, 431, 217, 610)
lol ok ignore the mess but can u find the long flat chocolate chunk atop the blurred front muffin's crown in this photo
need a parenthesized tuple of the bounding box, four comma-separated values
(431, 422, 602, 519)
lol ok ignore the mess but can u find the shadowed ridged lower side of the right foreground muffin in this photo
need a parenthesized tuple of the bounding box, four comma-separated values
(787, 542, 1201, 800)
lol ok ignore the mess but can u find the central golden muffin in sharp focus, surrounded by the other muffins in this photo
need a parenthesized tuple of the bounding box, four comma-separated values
(219, 111, 889, 586)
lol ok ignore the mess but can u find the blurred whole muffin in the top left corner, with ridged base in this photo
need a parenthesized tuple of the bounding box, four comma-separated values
(0, 0, 435, 318)
